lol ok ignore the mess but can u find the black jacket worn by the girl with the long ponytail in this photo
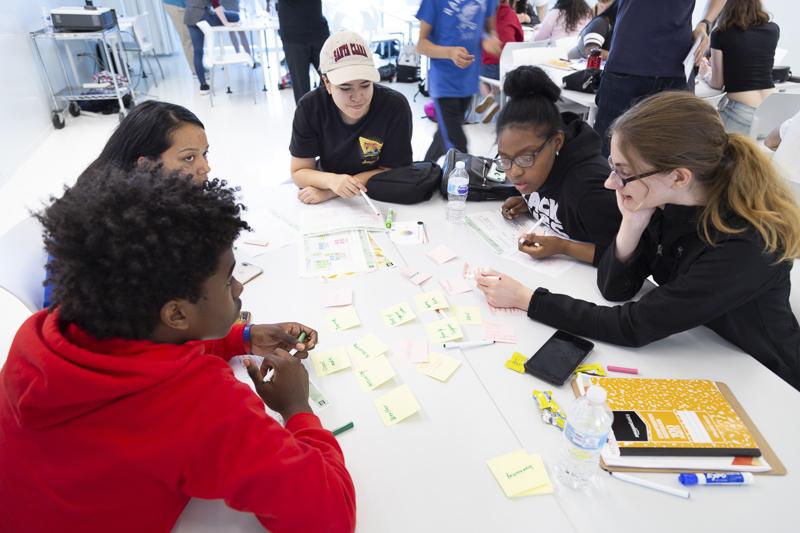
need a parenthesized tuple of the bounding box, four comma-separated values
(528, 205, 800, 390)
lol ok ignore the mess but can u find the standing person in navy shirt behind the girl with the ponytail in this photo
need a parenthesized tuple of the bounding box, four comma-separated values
(594, 0, 726, 156)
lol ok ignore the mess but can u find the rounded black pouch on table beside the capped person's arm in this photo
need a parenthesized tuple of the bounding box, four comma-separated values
(367, 161, 442, 205)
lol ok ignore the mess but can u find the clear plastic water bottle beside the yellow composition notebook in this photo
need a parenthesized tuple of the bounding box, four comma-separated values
(556, 385, 614, 489)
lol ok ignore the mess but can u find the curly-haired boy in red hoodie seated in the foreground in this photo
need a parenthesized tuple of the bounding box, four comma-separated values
(0, 167, 355, 533)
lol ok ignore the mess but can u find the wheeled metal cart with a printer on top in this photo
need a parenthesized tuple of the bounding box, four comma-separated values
(30, 25, 135, 130)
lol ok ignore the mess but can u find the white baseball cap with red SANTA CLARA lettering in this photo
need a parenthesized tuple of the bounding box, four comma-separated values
(319, 31, 381, 85)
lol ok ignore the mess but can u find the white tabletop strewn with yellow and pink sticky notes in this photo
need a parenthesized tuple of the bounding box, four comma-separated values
(176, 185, 800, 533)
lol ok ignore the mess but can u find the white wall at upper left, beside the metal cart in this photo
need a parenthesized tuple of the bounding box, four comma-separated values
(0, 0, 83, 186)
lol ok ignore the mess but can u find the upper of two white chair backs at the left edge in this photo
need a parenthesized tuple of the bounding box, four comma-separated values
(0, 217, 47, 313)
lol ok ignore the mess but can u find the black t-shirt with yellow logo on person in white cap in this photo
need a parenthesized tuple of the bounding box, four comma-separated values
(289, 83, 412, 175)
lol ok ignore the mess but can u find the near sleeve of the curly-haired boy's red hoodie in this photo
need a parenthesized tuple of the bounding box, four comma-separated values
(182, 369, 356, 533)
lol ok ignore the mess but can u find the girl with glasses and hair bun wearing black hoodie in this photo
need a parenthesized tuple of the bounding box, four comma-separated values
(495, 66, 621, 265)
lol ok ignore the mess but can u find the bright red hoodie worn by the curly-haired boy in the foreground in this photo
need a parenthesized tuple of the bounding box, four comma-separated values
(0, 311, 355, 533)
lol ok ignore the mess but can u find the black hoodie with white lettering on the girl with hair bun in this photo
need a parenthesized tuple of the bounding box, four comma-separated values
(527, 113, 622, 265)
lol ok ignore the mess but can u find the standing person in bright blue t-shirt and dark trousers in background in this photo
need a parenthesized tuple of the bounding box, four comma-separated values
(417, 0, 503, 161)
